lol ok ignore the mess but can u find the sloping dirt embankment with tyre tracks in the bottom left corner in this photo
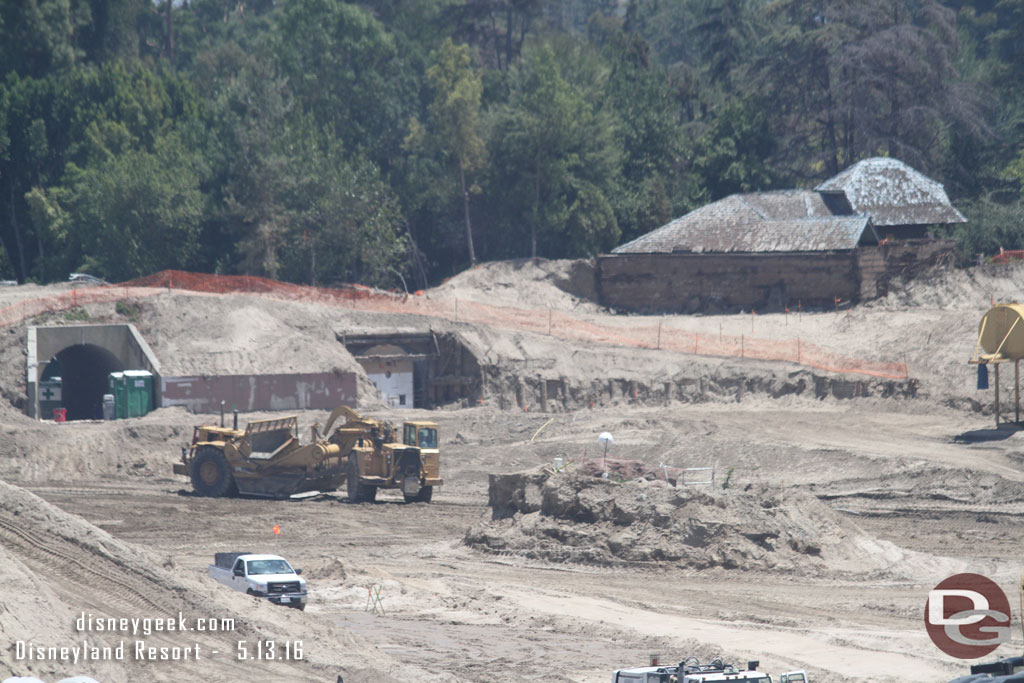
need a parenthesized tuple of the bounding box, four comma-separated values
(0, 481, 423, 683)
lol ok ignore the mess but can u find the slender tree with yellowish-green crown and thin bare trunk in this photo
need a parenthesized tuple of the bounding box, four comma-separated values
(406, 38, 486, 265)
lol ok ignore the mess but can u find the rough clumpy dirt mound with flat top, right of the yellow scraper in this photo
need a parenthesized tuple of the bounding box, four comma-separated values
(465, 461, 933, 573)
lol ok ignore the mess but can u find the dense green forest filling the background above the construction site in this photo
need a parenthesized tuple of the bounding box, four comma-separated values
(0, 0, 1024, 289)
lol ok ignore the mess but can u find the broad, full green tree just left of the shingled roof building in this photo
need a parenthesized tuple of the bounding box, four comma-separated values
(492, 42, 623, 257)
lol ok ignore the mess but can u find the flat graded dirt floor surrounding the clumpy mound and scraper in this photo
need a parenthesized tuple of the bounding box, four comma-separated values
(4, 401, 1024, 681)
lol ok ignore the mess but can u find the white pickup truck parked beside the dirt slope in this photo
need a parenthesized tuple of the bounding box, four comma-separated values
(208, 553, 306, 609)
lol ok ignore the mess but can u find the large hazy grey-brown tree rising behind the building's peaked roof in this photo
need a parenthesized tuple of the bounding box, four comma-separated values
(745, 0, 984, 180)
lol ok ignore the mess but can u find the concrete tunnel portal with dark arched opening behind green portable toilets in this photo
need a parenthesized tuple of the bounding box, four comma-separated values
(26, 324, 161, 420)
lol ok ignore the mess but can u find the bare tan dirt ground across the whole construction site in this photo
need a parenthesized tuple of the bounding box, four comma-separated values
(0, 263, 1024, 683)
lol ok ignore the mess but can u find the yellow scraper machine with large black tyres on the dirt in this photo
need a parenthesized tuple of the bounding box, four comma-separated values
(174, 405, 443, 503)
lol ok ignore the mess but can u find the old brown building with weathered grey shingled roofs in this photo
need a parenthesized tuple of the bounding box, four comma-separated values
(598, 158, 965, 311)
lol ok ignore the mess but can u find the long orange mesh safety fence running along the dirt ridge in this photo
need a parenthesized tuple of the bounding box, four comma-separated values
(0, 270, 909, 379)
